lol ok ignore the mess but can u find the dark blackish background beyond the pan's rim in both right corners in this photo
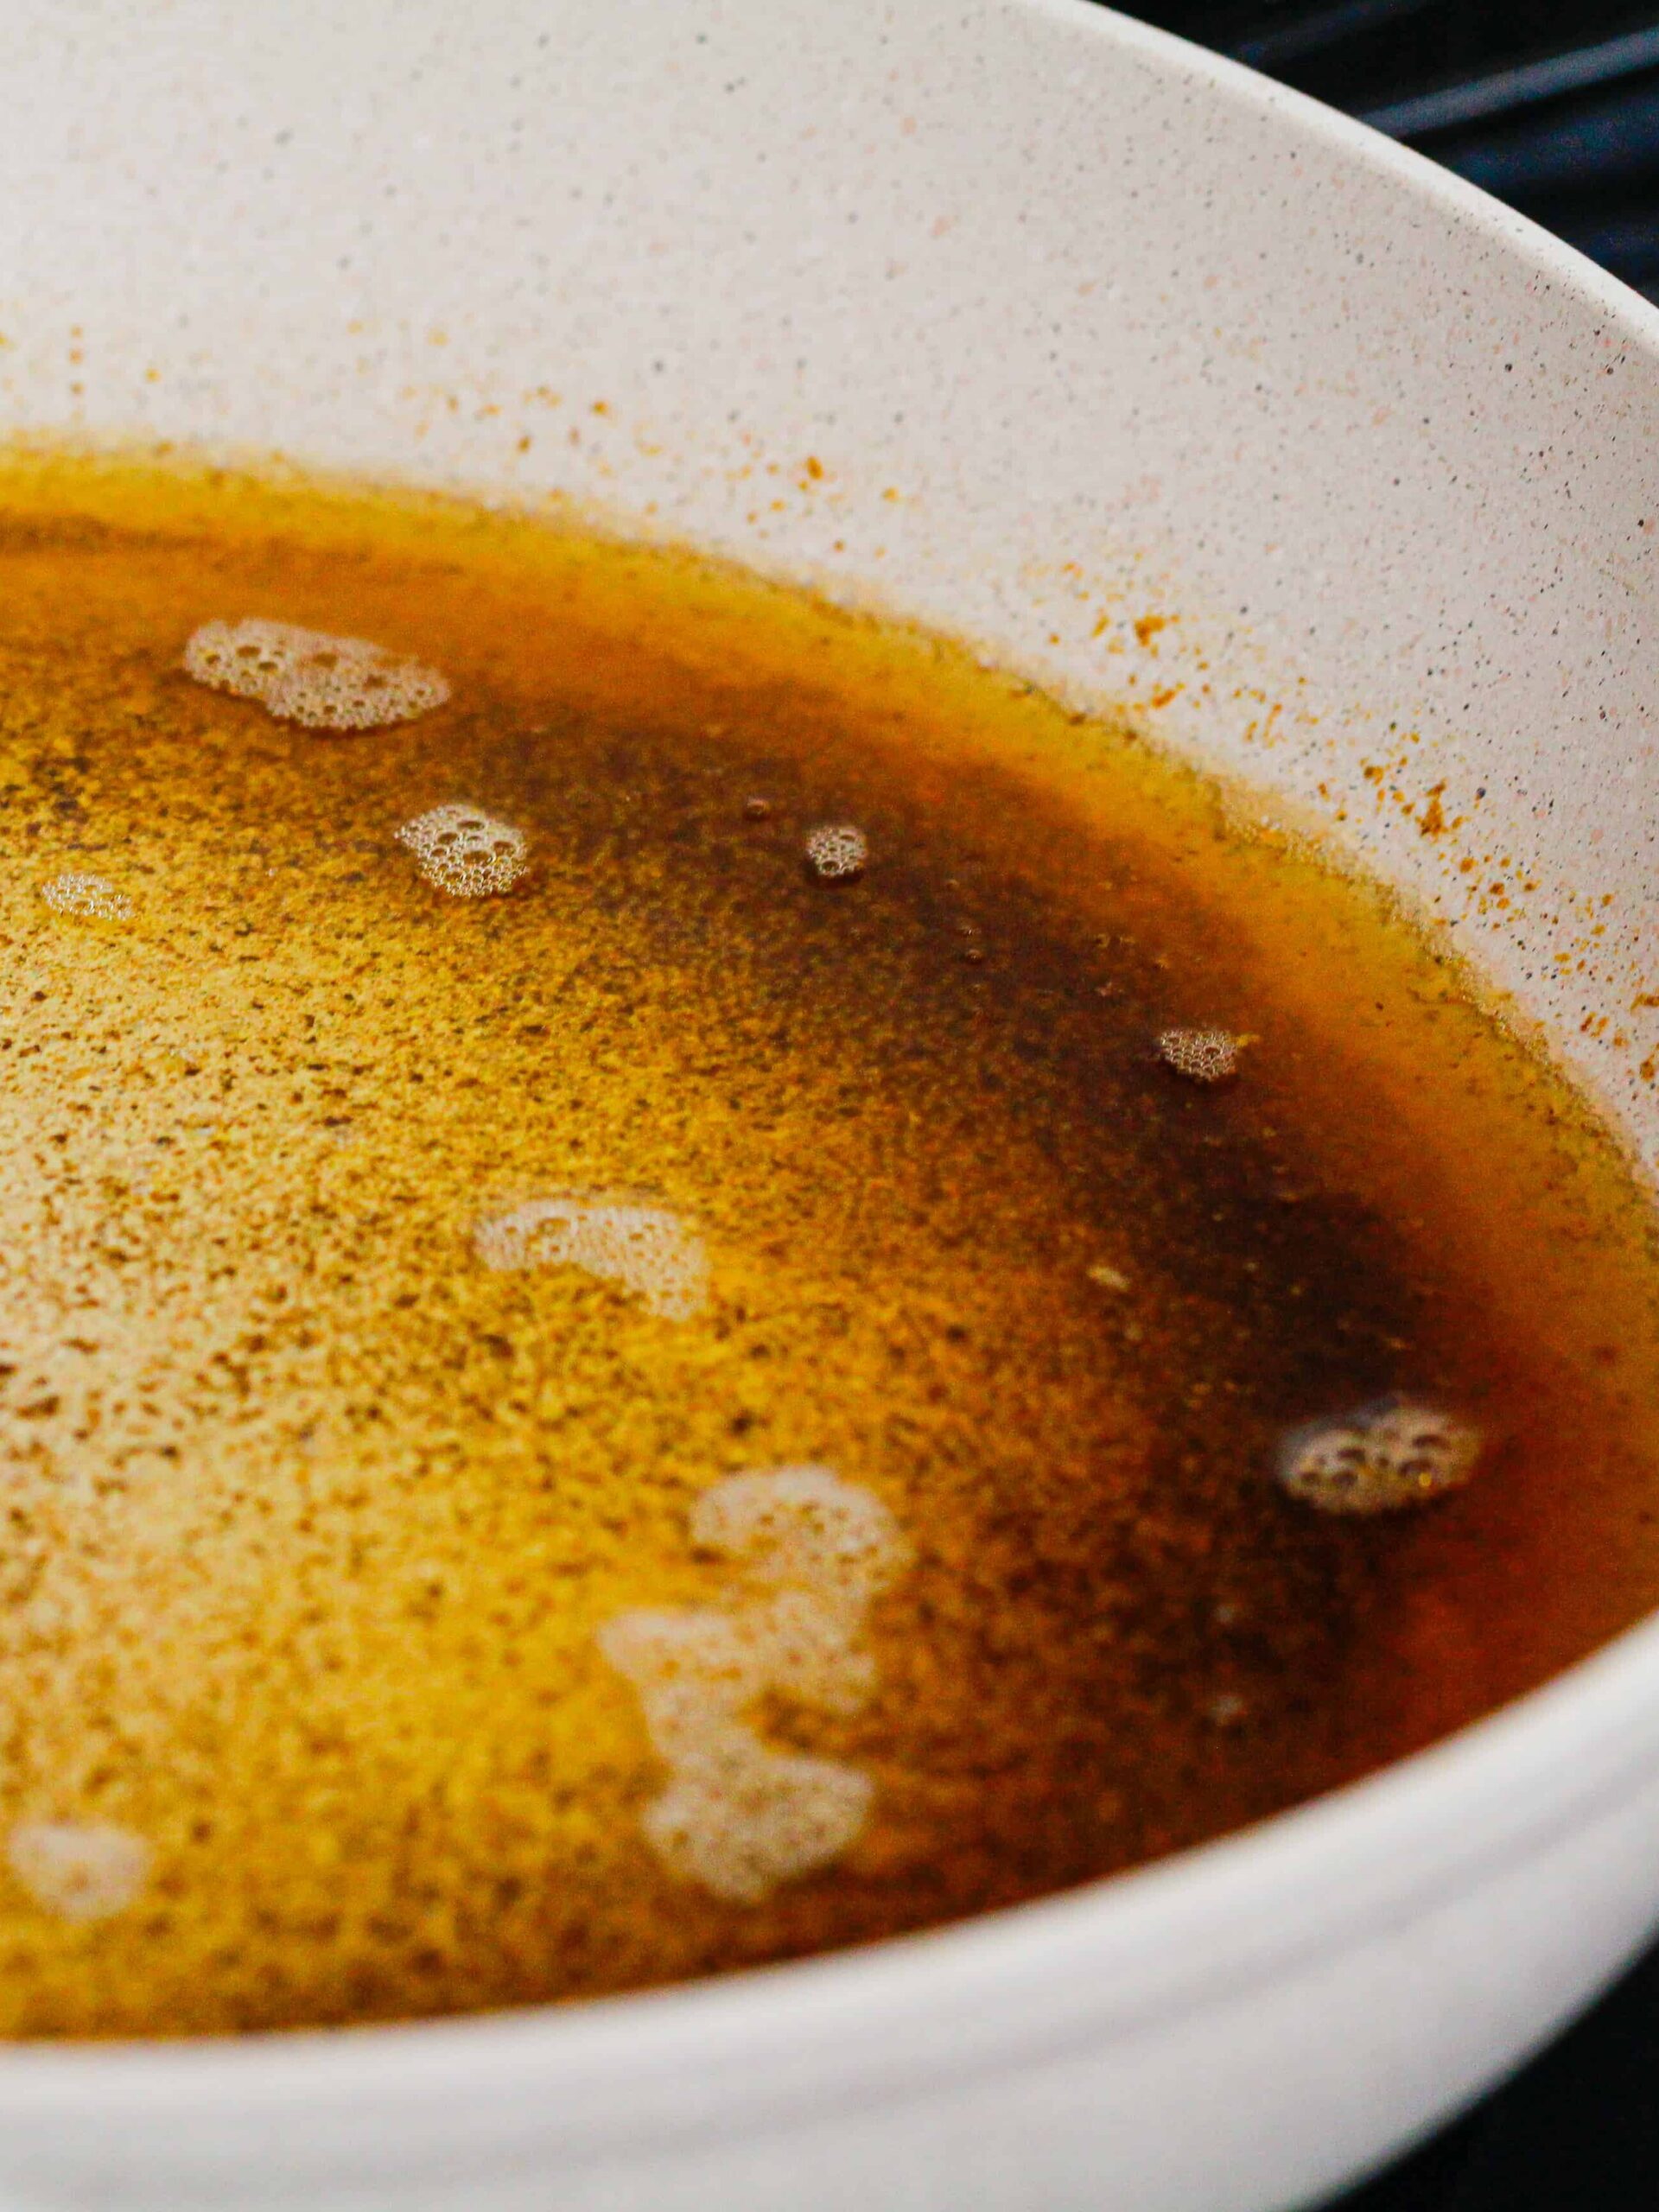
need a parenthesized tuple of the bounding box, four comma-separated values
(1092, 0, 1659, 2212)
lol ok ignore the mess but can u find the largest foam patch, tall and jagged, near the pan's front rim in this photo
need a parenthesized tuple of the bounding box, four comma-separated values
(600, 1466, 907, 1904)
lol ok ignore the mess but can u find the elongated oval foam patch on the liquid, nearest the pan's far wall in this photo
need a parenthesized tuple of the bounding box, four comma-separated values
(183, 617, 449, 730)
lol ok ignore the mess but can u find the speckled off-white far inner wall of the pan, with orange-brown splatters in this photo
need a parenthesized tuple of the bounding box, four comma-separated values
(0, 0, 1659, 1157)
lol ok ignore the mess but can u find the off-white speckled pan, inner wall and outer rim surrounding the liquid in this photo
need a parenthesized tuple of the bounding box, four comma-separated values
(0, 0, 1659, 2212)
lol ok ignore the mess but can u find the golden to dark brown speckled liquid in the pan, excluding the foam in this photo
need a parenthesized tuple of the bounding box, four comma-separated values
(0, 462, 1659, 2035)
